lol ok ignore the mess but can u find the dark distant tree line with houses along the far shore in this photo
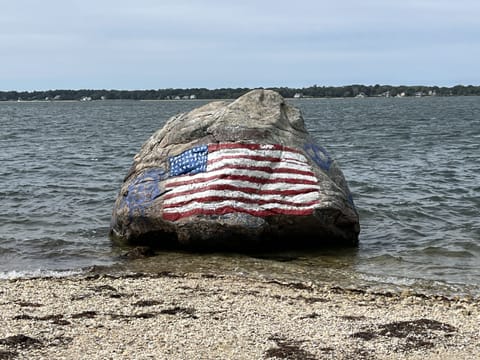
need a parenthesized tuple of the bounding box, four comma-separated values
(0, 84, 480, 101)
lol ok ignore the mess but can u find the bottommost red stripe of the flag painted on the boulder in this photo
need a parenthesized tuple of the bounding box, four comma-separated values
(163, 206, 313, 221)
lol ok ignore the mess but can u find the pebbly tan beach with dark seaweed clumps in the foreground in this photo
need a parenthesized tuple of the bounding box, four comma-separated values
(0, 273, 480, 360)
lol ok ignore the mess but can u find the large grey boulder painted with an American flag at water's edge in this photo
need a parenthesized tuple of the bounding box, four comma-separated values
(110, 90, 360, 250)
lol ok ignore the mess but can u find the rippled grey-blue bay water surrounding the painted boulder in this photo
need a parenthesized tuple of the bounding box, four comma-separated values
(0, 97, 480, 296)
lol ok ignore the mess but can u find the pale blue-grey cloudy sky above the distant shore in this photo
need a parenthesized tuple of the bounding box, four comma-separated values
(0, 0, 480, 90)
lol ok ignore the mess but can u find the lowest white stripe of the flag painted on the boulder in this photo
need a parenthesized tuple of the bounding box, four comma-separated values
(164, 190, 319, 207)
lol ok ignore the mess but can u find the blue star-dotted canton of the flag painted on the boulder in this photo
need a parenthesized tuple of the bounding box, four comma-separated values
(168, 145, 208, 176)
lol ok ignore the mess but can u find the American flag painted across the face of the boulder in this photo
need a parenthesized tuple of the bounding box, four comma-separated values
(163, 143, 319, 221)
